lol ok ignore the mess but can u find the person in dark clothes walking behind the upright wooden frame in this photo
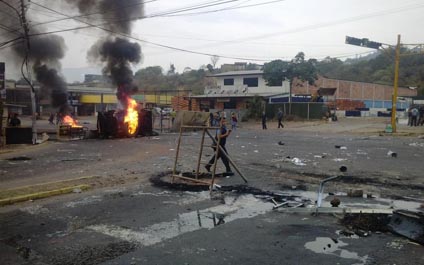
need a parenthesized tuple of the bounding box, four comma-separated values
(205, 117, 234, 176)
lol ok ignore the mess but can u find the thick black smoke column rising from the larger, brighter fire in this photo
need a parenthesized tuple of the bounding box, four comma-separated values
(66, 0, 144, 105)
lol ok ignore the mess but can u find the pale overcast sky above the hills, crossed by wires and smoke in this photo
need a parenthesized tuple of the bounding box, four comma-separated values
(0, 0, 424, 81)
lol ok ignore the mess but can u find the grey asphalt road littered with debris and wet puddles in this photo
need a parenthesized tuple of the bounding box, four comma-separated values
(0, 118, 424, 264)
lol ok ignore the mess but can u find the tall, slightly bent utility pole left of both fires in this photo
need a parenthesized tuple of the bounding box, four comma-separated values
(21, 0, 37, 144)
